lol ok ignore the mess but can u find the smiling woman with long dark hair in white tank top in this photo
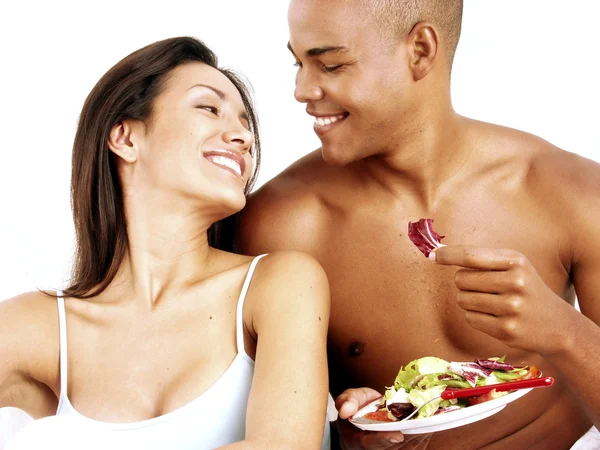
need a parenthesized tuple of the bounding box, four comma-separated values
(0, 37, 329, 449)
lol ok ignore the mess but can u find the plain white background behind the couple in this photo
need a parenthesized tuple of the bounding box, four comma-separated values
(0, 0, 600, 302)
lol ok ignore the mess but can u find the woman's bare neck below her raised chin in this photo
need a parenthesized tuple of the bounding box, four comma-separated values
(111, 186, 220, 310)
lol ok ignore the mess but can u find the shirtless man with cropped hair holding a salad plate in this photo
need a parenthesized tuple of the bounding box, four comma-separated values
(241, 0, 600, 450)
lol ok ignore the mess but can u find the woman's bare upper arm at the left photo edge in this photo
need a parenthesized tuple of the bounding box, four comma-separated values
(0, 292, 59, 418)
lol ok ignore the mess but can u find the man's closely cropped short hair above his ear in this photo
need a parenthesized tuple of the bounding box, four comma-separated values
(360, 0, 463, 67)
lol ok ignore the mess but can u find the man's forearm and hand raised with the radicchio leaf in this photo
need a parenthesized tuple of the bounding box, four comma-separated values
(433, 244, 600, 425)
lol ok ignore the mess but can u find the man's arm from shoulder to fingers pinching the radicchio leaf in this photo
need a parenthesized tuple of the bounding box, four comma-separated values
(434, 154, 600, 427)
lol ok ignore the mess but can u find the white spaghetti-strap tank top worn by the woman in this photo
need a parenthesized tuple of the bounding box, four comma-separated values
(7, 255, 330, 450)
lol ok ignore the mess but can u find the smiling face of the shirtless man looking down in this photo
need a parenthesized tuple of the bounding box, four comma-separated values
(288, 0, 413, 165)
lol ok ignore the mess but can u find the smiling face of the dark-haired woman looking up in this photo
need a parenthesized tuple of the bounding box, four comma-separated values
(123, 63, 254, 218)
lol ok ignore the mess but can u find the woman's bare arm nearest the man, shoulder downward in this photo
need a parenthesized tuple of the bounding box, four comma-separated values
(218, 252, 329, 450)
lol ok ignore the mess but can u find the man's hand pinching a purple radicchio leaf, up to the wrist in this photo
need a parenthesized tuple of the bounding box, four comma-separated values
(430, 246, 577, 356)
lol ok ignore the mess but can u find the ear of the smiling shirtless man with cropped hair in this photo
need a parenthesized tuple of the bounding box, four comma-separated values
(408, 22, 439, 81)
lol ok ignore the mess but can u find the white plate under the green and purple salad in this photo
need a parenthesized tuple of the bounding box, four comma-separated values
(350, 389, 531, 434)
